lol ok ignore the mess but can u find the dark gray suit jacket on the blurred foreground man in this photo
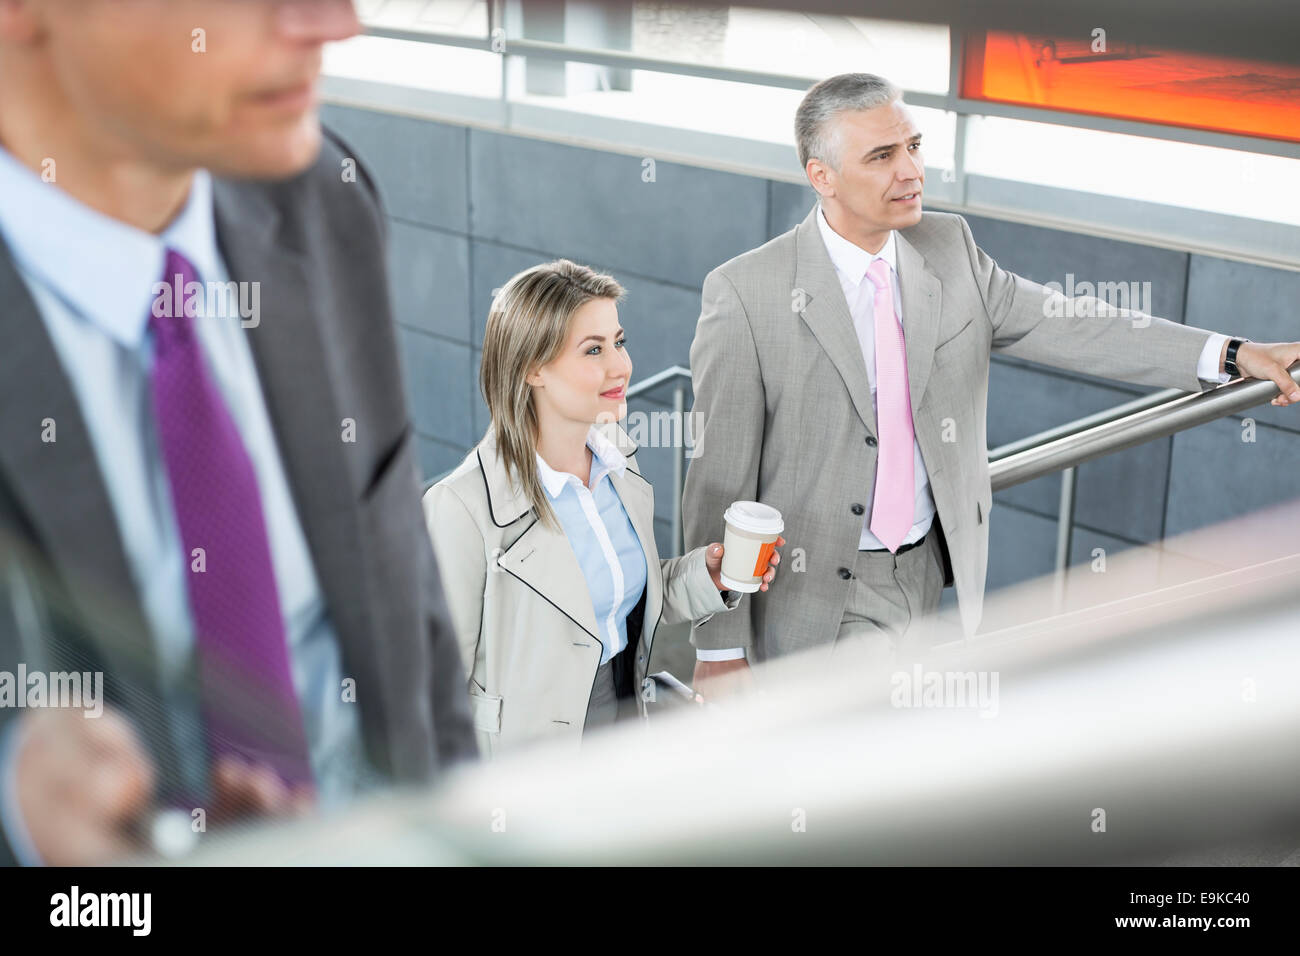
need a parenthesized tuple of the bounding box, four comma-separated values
(0, 133, 477, 862)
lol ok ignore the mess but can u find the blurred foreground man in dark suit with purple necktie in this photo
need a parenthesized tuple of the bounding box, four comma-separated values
(0, 0, 476, 864)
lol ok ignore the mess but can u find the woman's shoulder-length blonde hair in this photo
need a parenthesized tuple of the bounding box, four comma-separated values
(478, 259, 624, 531)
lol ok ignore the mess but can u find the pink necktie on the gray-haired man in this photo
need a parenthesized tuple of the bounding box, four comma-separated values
(867, 259, 917, 551)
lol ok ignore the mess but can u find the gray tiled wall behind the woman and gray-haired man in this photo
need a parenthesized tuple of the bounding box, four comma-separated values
(324, 105, 1300, 605)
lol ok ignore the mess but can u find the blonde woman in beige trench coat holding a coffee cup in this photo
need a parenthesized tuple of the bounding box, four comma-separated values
(424, 259, 784, 754)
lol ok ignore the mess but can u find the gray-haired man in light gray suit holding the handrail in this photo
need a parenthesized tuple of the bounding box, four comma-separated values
(684, 74, 1300, 693)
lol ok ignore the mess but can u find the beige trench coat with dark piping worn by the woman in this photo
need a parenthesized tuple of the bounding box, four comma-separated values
(424, 424, 741, 756)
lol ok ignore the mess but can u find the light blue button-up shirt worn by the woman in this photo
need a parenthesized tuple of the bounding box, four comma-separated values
(537, 427, 646, 663)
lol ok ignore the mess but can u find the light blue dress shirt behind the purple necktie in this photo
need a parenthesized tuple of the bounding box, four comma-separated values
(0, 148, 374, 862)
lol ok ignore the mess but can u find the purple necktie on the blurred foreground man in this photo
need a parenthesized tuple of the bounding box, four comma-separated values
(150, 250, 312, 786)
